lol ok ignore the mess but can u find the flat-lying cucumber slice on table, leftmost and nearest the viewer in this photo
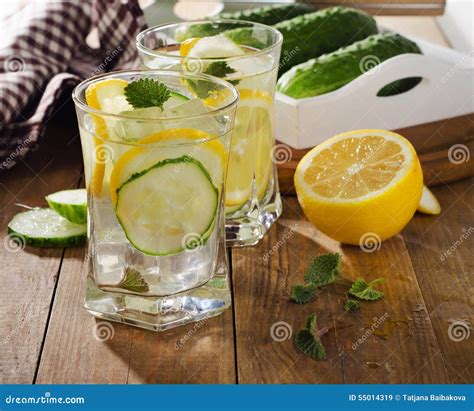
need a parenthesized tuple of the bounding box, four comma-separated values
(8, 208, 87, 247)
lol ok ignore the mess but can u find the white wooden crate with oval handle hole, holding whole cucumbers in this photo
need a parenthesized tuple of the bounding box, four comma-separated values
(275, 37, 474, 149)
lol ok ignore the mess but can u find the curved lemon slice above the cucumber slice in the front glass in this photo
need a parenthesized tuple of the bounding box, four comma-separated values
(110, 128, 227, 205)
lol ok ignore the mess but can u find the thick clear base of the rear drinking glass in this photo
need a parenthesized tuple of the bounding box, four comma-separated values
(225, 191, 283, 247)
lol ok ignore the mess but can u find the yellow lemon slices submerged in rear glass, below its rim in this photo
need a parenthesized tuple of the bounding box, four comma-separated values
(225, 89, 273, 212)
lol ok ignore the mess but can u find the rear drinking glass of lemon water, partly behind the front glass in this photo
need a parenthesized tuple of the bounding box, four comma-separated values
(136, 20, 282, 246)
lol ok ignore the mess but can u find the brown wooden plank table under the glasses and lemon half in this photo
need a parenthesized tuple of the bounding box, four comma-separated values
(0, 18, 474, 383)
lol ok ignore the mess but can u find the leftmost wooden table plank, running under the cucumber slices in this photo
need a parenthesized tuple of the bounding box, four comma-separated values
(0, 101, 82, 383)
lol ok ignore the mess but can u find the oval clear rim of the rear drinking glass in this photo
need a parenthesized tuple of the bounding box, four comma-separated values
(135, 19, 283, 61)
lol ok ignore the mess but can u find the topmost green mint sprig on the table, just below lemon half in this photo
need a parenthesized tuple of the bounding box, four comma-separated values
(291, 253, 341, 304)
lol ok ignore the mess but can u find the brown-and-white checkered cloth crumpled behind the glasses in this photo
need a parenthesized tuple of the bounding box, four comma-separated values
(0, 0, 145, 171)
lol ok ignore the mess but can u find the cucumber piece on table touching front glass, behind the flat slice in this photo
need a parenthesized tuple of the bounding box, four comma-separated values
(46, 188, 87, 224)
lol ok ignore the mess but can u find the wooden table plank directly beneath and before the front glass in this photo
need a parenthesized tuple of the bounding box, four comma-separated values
(36, 245, 235, 384)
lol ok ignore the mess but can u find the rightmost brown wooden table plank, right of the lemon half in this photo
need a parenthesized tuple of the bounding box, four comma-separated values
(404, 179, 474, 384)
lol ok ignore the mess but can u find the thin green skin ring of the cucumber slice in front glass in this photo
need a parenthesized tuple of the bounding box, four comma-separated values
(115, 155, 220, 257)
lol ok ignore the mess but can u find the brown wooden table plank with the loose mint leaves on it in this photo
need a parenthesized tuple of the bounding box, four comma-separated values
(232, 197, 449, 384)
